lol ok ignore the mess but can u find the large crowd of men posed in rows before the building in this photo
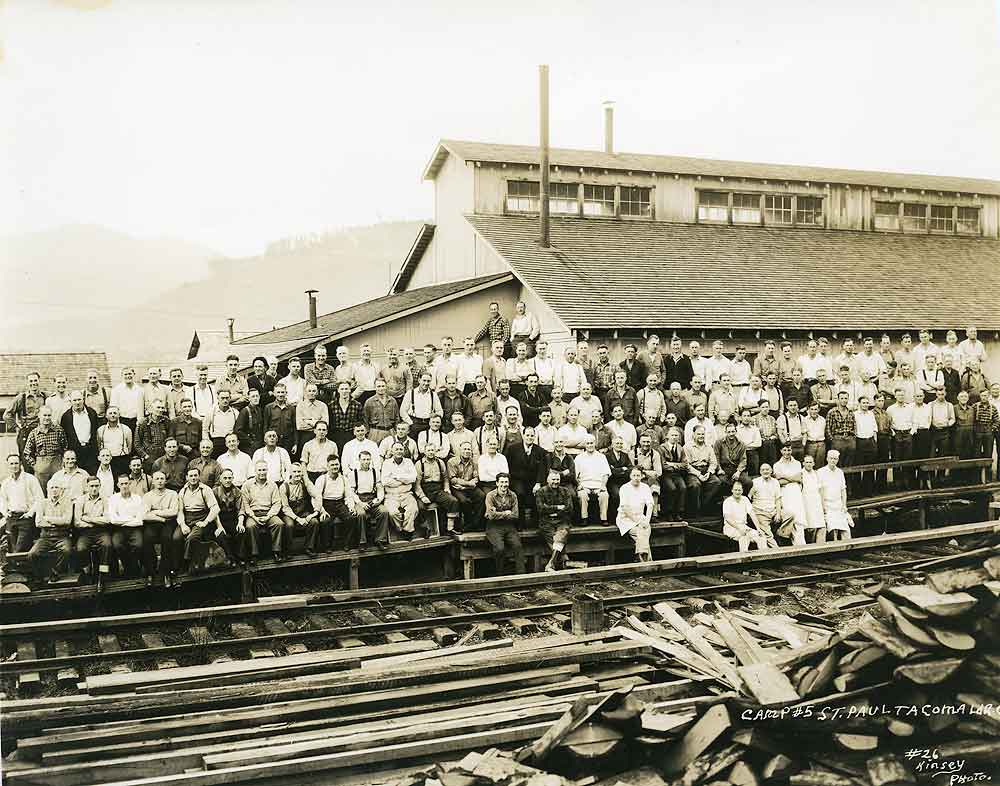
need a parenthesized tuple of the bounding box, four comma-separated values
(0, 304, 1000, 586)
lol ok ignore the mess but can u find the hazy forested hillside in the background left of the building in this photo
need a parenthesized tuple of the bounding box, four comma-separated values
(0, 222, 420, 359)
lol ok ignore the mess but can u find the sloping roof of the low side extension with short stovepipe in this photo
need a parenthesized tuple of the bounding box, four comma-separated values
(236, 272, 511, 348)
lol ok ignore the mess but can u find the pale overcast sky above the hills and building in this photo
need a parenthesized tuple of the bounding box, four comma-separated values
(0, 0, 1000, 255)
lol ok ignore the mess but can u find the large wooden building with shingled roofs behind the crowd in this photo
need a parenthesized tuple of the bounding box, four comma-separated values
(232, 140, 1000, 378)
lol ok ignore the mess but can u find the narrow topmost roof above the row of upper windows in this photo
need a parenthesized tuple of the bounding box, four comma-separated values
(424, 139, 1000, 194)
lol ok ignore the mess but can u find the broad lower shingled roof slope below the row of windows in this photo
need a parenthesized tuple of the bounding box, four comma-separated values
(466, 215, 1000, 330)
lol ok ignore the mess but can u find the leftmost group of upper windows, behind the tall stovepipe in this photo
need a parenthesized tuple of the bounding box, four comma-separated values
(507, 180, 653, 218)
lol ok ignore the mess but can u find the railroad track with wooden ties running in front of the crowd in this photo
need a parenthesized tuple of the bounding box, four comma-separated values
(0, 523, 995, 698)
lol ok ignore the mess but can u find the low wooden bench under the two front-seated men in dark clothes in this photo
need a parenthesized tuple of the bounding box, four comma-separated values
(452, 521, 687, 579)
